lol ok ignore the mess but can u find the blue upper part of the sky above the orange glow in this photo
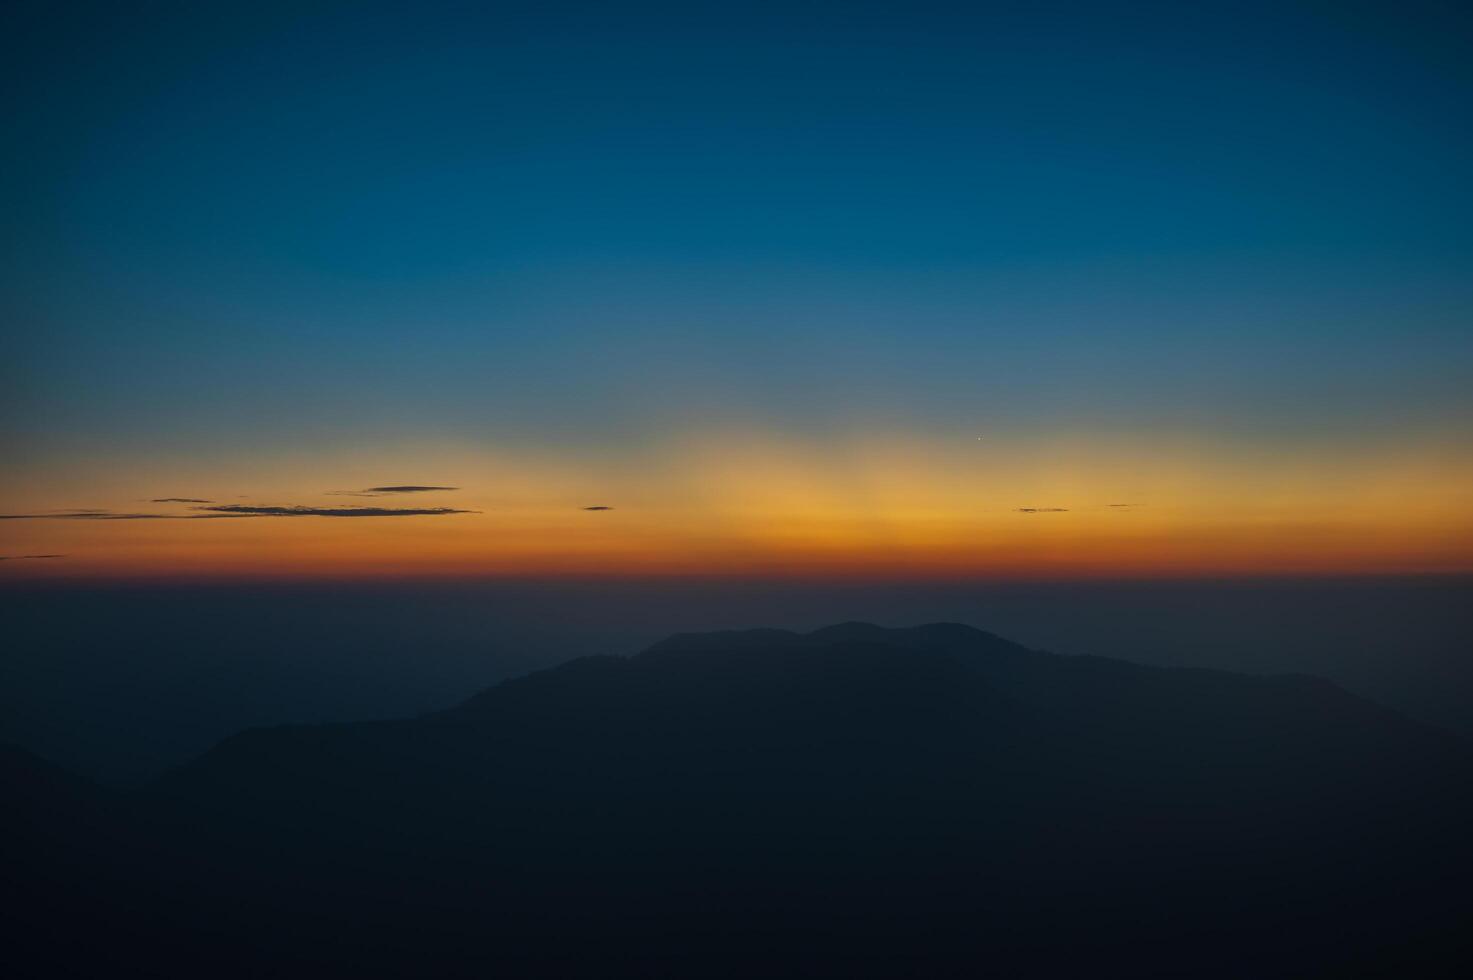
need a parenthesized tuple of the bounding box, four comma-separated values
(0, 3, 1473, 461)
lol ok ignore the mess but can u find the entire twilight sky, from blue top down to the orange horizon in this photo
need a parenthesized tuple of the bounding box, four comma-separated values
(0, 1, 1473, 581)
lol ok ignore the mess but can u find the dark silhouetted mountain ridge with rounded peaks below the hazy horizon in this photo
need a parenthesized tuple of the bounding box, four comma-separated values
(2, 623, 1473, 977)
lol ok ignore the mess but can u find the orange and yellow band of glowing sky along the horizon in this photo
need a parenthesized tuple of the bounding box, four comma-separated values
(0, 433, 1473, 581)
